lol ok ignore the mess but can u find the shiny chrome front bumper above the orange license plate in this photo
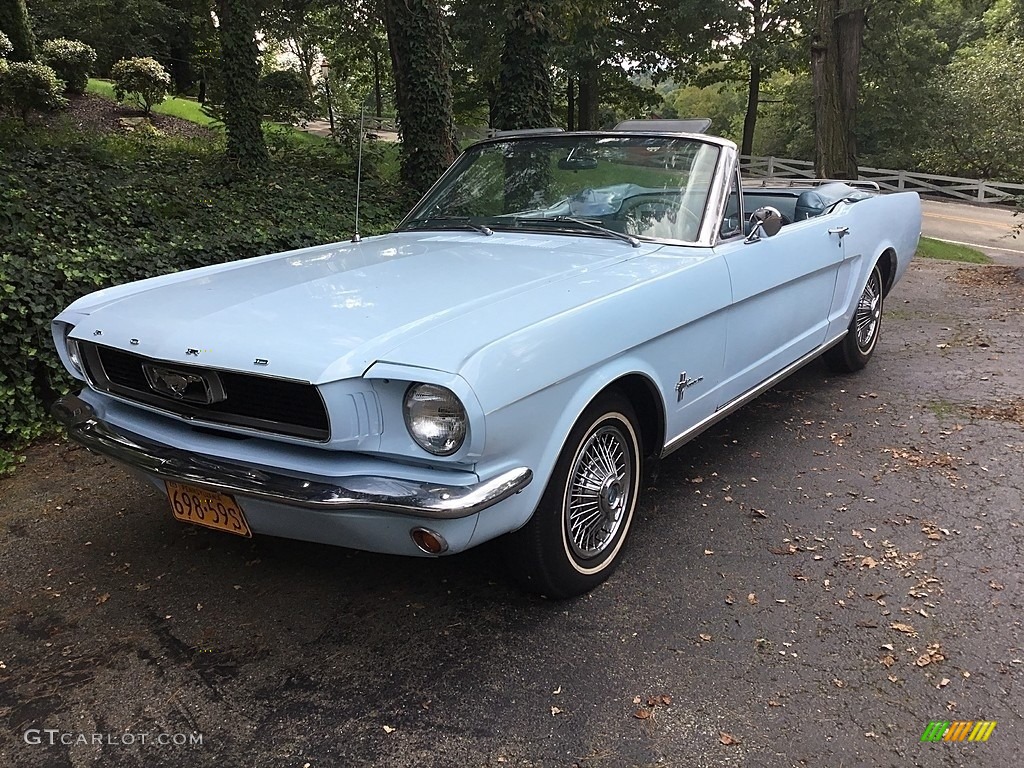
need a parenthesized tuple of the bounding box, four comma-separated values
(50, 394, 534, 519)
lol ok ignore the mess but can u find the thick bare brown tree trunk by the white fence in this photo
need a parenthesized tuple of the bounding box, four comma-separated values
(811, 0, 870, 179)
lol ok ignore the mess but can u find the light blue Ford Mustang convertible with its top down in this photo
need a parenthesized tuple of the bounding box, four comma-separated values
(53, 122, 921, 598)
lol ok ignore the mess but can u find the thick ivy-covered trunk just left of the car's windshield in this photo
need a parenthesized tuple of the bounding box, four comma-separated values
(384, 0, 456, 195)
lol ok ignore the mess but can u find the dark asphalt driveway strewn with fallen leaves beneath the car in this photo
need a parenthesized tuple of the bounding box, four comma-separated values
(0, 260, 1024, 768)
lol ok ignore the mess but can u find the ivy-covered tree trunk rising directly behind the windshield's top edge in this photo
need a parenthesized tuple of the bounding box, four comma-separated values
(494, 0, 553, 130)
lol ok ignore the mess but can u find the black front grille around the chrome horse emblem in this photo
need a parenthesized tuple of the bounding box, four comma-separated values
(80, 342, 331, 441)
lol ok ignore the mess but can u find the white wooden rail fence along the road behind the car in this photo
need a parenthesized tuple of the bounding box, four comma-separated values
(740, 155, 1024, 203)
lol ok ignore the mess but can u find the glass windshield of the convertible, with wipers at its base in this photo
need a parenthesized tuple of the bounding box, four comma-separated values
(399, 134, 719, 243)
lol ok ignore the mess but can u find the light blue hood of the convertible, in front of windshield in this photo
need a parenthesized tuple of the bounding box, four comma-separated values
(68, 232, 659, 383)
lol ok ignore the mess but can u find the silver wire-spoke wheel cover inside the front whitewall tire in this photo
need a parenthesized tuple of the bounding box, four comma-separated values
(564, 426, 633, 560)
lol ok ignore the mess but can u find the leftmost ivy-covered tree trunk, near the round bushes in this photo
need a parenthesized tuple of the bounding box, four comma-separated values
(217, 0, 269, 171)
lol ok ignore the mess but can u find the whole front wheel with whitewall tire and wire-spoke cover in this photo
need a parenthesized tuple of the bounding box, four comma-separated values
(505, 393, 642, 599)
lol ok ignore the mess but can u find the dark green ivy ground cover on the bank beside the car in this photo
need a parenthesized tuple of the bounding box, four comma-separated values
(0, 122, 401, 472)
